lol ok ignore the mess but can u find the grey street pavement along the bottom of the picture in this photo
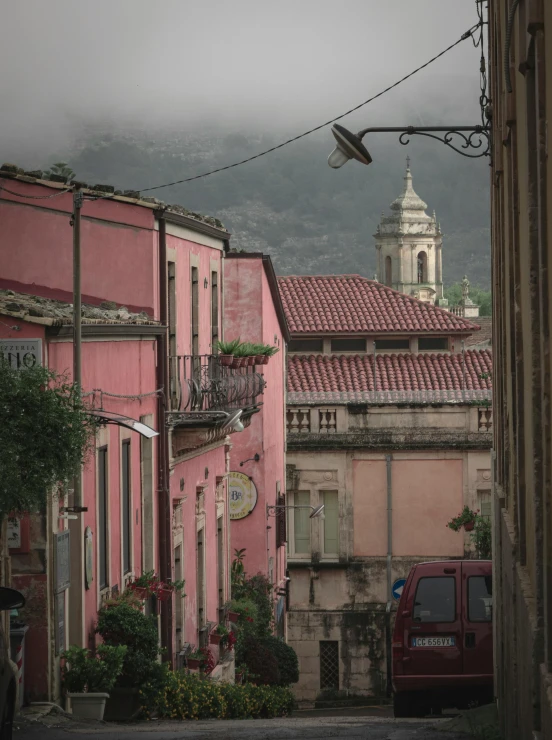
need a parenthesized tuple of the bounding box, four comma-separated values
(14, 710, 468, 740)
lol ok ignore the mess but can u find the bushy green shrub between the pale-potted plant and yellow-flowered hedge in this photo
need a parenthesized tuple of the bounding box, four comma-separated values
(96, 598, 165, 688)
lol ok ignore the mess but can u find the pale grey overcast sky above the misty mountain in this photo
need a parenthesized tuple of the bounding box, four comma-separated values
(0, 0, 479, 161)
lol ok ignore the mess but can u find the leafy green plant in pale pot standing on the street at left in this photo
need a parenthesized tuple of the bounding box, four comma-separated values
(61, 645, 127, 720)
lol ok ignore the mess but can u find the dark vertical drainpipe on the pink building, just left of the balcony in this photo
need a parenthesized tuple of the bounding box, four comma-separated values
(155, 211, 173, 663)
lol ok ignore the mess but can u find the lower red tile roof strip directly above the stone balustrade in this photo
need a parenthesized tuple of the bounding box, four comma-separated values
(288, 350, 492, 403)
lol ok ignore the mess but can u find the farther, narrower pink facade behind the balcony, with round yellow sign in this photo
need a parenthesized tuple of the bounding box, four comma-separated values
(224, 252, 289, 637)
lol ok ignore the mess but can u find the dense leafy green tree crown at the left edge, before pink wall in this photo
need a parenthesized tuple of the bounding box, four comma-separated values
(0, 357, 98, 517)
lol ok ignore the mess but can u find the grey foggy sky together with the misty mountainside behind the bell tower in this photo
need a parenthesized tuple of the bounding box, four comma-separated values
(0, 0, 490, 286)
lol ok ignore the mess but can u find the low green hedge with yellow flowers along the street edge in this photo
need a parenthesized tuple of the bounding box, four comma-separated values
(141, 671, 294, 720)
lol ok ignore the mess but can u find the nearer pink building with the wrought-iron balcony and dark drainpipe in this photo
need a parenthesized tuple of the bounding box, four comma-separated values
(0, 169, 264, 699)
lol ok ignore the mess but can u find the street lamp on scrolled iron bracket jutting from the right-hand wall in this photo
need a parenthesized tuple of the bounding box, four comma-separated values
(328, 123, 490, 169)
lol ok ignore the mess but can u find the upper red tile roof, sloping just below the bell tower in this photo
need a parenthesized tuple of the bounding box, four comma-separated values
(278, 275, 479, 334)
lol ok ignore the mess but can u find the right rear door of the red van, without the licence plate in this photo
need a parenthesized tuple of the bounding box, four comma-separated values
(462, 560, 493, 676)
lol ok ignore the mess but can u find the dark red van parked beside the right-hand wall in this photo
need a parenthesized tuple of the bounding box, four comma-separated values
(393, 560, 493, 717)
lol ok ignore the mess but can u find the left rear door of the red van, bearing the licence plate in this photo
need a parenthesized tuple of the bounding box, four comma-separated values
(403, 562, 463, 676)
